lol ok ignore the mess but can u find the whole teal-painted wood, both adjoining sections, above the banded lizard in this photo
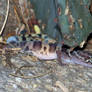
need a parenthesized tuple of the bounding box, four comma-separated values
(31, 0, 92, 47)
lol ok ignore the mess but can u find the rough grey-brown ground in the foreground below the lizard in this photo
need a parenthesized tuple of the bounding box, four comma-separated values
(0, 55, 92, 92)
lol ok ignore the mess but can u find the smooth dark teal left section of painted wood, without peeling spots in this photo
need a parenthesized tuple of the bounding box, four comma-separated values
(31, 0, 62, 41)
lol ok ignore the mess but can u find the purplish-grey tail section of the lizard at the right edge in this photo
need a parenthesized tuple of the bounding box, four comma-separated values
(61, 52, 92, 68)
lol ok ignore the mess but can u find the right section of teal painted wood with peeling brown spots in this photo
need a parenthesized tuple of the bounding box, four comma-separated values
(58, 0, 92, 47)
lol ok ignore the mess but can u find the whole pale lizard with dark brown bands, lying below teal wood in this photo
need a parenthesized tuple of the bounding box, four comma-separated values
(8, 33, 92, 67)
